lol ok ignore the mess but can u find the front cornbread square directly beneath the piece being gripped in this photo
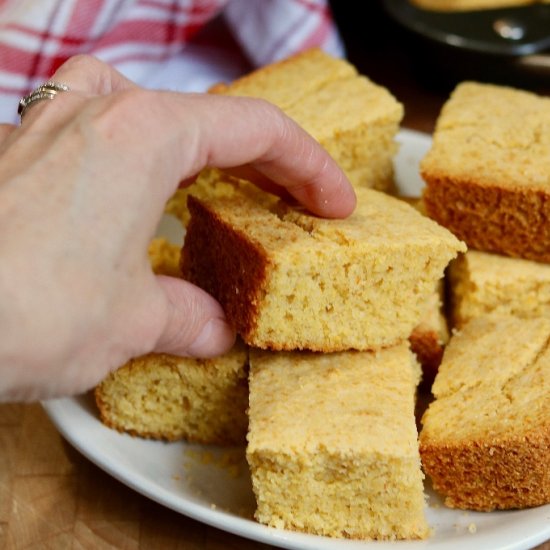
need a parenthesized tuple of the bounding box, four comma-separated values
(247, 344, 428, 539)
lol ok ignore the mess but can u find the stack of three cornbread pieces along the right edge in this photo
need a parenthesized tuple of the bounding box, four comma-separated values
(420, 82, 550, 510)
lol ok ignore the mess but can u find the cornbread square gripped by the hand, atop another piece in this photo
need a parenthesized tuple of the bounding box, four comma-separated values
(182, 189, 465, 352)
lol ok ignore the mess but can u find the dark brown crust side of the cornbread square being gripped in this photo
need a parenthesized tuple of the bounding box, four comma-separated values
(181, 195, 269, 341)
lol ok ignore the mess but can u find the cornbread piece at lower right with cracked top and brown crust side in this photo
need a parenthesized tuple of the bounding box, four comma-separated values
(420, 316, 550, 510)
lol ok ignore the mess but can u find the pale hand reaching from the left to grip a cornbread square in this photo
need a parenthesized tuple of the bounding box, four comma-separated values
(0, 56, 355, 401)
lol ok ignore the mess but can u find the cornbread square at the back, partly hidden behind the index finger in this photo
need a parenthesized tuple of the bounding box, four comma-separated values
(210, 48, 404, 194)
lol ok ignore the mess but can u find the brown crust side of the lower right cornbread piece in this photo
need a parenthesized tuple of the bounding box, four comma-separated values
(420, 425, 550, 511)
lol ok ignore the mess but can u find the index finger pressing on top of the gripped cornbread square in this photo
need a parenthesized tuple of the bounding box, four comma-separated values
(177, 96, 356, 218)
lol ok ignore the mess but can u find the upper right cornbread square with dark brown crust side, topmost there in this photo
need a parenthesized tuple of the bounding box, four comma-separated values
(420, 82, 550, 263)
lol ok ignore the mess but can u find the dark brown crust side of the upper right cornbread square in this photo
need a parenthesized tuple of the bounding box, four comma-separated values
(422, 176, 550, 263)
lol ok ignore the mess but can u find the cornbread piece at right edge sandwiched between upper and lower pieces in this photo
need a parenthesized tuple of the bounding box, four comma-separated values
(447, 250, 550, 327)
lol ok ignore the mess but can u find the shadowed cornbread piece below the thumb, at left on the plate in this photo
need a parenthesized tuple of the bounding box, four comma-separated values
(94, 342, 248, 444)
